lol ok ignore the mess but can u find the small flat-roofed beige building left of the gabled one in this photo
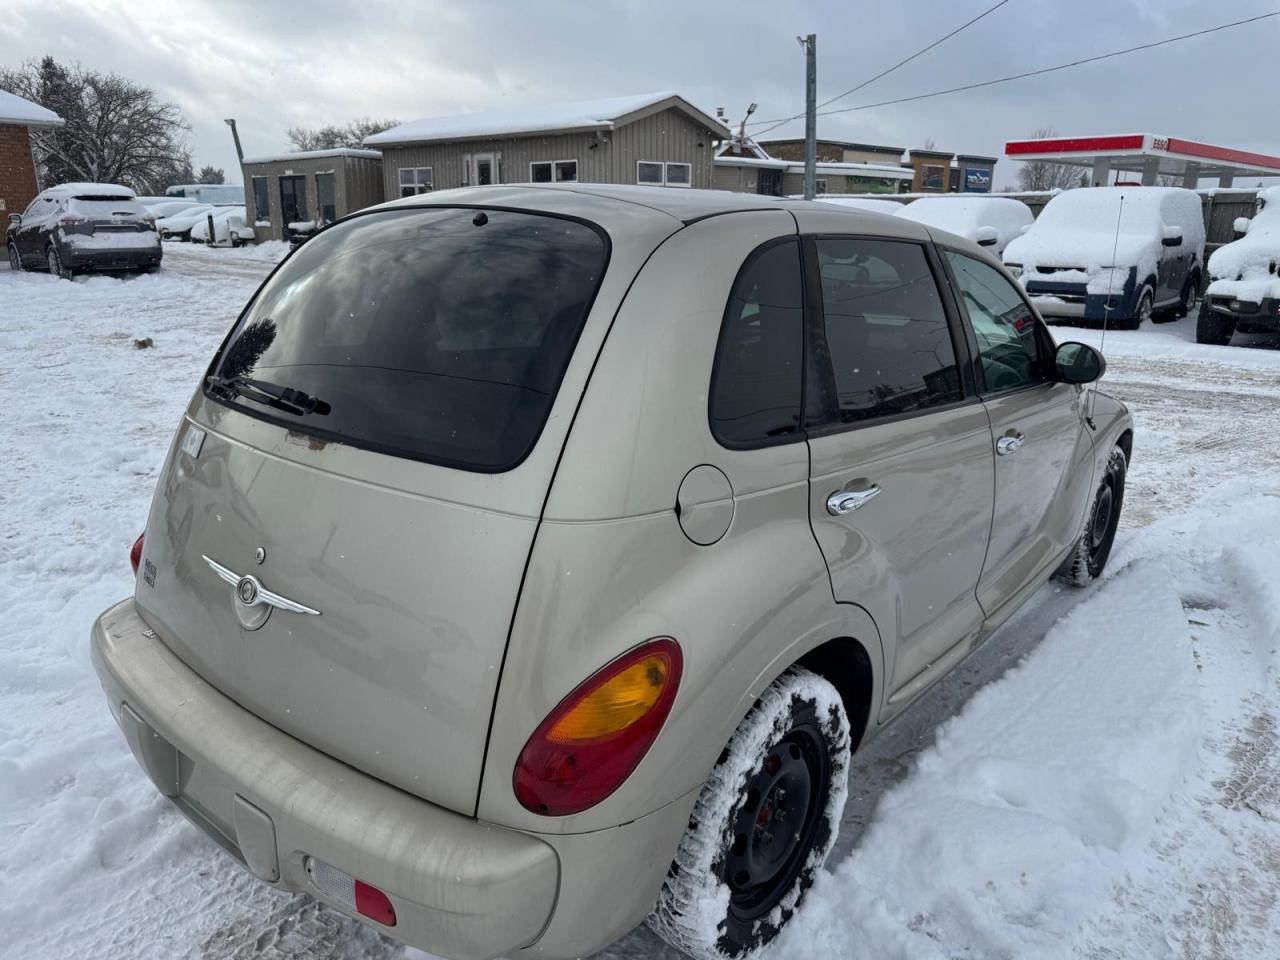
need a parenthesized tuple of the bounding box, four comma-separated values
(241, 148, 384, 241)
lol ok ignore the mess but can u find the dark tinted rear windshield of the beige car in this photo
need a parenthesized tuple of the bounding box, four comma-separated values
(206, 207, 608, 472)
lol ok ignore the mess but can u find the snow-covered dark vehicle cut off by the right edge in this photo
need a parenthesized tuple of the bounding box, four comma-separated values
(1196, 187, 1280, 344)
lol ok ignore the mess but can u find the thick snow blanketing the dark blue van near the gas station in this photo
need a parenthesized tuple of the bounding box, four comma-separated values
(1004, 187, 1204, 293)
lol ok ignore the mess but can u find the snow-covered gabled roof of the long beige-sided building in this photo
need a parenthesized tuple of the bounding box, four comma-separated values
(364, 91, 730, 146)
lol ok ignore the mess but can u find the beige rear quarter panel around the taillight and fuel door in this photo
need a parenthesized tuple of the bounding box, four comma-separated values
(477, 211, 881, 834)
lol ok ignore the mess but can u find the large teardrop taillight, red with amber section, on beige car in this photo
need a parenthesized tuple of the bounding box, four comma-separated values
(513, 637, 684, 817)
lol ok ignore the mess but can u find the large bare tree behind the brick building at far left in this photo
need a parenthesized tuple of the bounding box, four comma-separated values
(0, 56, 191, 193)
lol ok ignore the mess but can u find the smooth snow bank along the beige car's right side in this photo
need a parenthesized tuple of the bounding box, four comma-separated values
(777, 562, 1202, 960)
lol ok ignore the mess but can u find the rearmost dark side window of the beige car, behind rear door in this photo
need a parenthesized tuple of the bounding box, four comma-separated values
(710, 239, 804, 448)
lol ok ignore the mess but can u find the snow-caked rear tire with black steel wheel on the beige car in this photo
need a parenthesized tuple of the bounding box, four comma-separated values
(648, 667, 851, 960)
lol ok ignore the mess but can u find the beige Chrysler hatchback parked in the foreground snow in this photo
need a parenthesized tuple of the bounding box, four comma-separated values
(92, 183, 1133, 957)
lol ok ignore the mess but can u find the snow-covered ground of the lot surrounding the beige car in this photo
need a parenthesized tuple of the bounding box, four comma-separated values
(0, 244, 1280, 960)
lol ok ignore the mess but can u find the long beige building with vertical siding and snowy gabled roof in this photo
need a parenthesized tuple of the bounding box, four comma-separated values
(365, 92, 728, 200)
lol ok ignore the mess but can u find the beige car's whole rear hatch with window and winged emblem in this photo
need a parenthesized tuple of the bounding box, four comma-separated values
(137, 207, 622, 814)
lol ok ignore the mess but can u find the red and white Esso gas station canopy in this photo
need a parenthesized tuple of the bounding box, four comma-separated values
(1005, 133, 1280, 189)
